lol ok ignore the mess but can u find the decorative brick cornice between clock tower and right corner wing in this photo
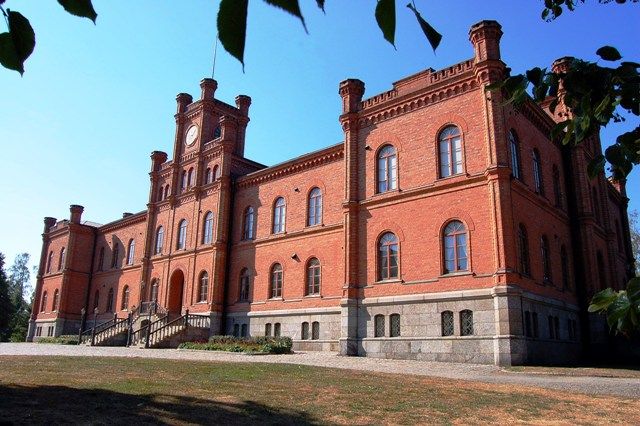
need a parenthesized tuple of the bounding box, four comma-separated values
(237, 143, 344, 188)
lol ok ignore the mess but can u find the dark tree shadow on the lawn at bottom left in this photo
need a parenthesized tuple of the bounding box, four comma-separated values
(0, 385, 320, 425)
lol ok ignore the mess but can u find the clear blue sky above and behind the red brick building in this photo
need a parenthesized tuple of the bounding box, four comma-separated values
(0, 0, 640, 288)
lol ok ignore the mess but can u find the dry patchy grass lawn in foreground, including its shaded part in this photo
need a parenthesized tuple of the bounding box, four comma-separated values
(0, 357, 640, 425)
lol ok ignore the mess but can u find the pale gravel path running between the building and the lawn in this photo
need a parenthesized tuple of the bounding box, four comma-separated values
(0, 343, 640, 398)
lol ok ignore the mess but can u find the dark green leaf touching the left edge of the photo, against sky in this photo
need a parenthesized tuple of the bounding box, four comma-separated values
(0, 9, 36, 75)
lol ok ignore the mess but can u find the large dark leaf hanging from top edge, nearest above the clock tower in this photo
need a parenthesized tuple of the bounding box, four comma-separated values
(217, 0, 249, 71)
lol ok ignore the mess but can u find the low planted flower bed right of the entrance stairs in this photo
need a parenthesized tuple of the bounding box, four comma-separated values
(178, 336, 293, 354)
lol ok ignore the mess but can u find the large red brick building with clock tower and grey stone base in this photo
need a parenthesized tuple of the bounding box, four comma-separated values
(29, 21, 633, 364)
